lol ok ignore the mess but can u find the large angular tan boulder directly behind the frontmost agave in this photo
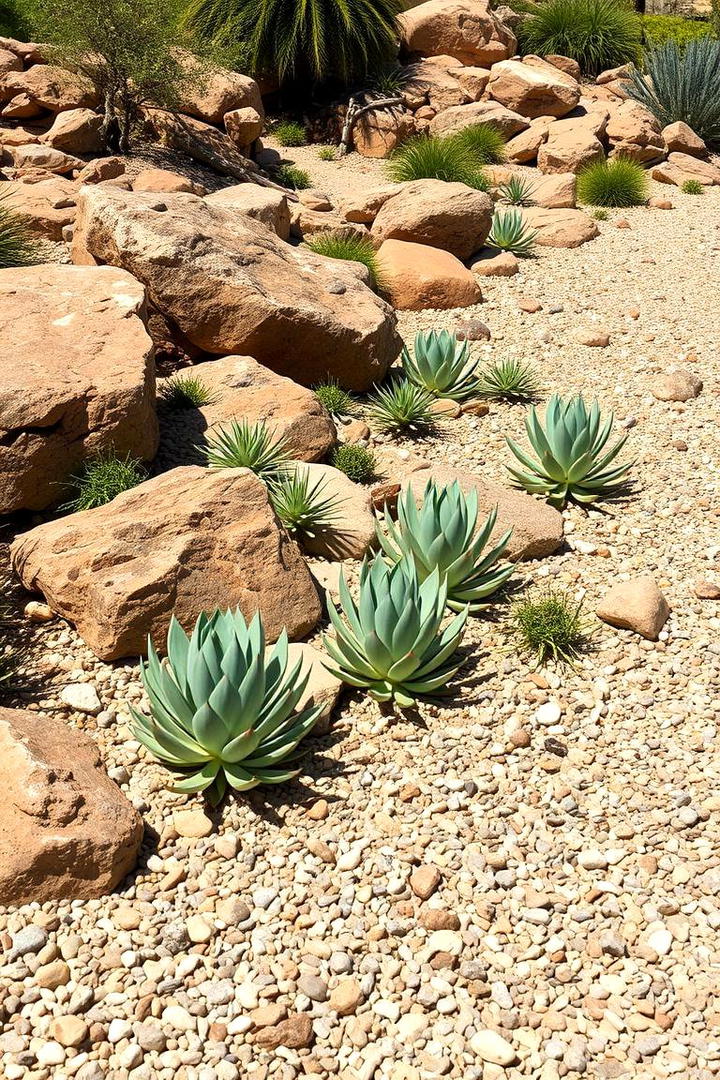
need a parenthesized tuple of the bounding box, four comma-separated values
(11, 465, 321, 660)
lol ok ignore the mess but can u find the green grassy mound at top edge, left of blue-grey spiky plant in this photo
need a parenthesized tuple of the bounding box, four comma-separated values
(518, 0, 641, 76)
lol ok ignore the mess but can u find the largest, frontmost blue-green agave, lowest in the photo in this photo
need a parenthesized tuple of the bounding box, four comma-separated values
(133, 609, 322, 805)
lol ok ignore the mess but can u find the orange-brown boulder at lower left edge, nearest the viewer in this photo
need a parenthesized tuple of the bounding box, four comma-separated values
(0, 708, 142, 906)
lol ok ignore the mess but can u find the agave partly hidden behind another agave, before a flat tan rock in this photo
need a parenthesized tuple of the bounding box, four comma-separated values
(377, 480, 513, 615)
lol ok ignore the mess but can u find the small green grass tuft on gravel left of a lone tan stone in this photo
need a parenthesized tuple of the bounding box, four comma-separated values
(510, 588, 589, 664)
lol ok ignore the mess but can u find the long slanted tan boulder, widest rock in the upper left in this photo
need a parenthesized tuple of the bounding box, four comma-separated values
(76, 186, 400, 390)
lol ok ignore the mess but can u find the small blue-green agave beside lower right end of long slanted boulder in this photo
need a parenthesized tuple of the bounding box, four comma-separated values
(402, 330, 478, 401)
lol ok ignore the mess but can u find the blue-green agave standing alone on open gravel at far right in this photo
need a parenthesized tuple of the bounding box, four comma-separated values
(506, 394, 633, 507)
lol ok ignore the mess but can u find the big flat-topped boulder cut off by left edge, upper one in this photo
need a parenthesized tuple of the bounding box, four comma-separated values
(0, 264, 158, 514)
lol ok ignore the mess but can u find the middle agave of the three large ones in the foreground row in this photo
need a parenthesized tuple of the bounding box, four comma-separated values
(323, 557, 467, 708)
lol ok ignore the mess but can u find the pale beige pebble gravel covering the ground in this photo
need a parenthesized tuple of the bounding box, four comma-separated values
(0, 148, 720, 1080)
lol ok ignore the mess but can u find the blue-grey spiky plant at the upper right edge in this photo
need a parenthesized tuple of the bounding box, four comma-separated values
(625, 38, 720, 143)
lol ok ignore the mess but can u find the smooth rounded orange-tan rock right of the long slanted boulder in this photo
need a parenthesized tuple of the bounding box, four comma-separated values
(378, 240, 483, 311)
